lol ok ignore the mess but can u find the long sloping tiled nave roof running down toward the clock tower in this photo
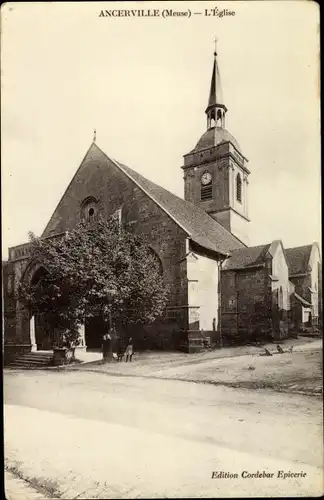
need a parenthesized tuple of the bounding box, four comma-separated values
(93, 148, 244, 255)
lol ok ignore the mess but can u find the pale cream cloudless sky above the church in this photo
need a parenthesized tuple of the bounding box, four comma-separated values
(1, 1, 321, 259)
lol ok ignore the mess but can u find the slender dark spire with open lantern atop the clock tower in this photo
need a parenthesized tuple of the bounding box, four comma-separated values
(205, 38, 227, 130)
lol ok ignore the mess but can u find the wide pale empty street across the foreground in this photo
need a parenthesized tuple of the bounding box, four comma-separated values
(4, 370, 323, 499)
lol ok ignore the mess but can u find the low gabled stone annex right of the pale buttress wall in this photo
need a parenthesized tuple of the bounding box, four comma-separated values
(221, 240, 293, 342)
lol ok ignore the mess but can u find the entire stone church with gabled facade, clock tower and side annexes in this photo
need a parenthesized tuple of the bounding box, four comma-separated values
(3, 47, 320, 360)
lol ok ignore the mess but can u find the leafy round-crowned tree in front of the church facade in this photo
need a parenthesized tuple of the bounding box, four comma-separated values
(19, 219, 168, 350)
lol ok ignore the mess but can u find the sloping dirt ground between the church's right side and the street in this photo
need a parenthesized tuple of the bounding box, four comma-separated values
(70, 339, 323, 397)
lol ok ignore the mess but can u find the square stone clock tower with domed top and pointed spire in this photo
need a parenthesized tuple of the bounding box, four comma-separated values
(182, 43, 250, 245)
